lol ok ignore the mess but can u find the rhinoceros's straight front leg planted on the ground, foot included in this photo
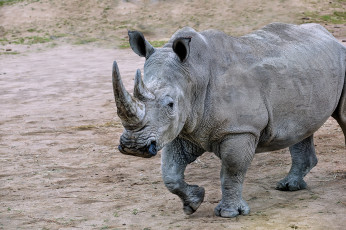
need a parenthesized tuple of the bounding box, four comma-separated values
(214, 134, 257, 217)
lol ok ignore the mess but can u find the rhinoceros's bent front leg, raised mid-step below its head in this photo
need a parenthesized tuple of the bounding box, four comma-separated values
(162, 138, 205, 215)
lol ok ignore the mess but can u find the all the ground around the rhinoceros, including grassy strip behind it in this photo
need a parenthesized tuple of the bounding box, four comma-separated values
(0, 0, 346, 230)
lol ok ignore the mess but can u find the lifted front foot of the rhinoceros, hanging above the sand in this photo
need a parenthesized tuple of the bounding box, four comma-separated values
(183, 185, 205, 215)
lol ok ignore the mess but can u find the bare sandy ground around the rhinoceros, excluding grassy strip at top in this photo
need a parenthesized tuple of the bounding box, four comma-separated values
(0, 43, 346, 230)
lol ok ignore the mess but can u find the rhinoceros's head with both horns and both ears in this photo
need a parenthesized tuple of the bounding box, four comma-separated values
(112, 31, 190, 158)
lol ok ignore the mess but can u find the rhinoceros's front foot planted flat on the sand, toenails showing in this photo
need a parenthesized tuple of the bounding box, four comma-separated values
(214, 199, 250, 218)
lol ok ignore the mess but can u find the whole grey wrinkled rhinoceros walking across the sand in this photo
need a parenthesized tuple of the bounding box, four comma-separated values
(113, 23, 346, 217)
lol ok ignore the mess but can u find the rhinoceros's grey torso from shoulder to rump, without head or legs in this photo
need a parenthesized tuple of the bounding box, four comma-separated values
(167, 23, 346, 152)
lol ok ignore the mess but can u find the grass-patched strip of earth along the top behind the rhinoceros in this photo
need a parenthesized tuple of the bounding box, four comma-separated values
(0, 0, 346, 47)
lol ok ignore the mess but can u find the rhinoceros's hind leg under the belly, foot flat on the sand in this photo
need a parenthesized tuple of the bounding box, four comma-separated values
(276, 135, 317, 191)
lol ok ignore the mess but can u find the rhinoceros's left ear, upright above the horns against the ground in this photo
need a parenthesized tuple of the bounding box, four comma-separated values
(128, 31, 155, 59)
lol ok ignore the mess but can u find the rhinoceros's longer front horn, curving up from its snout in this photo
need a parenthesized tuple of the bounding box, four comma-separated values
(112, 61, 145, 126)
